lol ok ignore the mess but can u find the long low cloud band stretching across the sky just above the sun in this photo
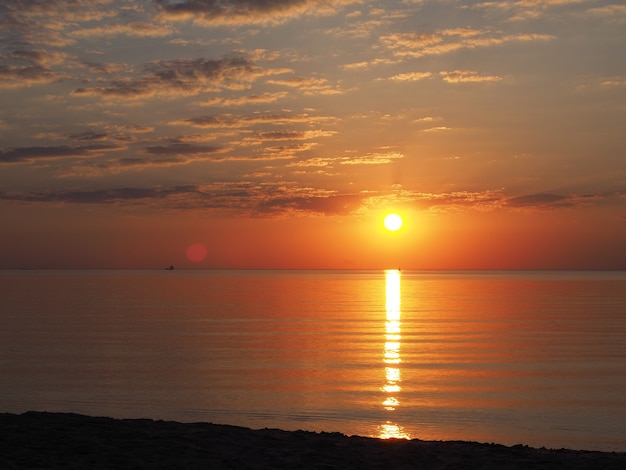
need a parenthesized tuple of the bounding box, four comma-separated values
(0, 185, 624, 217)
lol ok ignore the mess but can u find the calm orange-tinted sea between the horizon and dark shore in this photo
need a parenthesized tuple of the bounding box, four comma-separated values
(0, 271, 626, 451)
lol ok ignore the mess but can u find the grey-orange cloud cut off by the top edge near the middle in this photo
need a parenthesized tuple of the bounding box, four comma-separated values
(153, 0, 360, 26)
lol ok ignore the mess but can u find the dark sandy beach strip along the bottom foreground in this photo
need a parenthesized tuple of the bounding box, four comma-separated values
(0, 412, 626, 470)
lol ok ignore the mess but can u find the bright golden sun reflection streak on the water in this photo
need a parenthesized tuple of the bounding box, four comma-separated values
(379, 269, 410, 439)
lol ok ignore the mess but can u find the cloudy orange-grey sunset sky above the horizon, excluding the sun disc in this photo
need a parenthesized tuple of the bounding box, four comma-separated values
(0, 0, 626, 269)
